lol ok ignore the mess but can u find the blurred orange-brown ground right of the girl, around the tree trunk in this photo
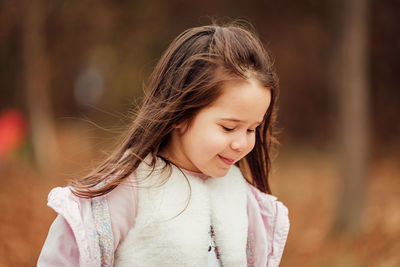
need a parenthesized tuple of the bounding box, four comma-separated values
(273, 152, 400, 267)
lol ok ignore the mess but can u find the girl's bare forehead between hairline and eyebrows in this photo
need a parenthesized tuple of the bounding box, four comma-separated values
(206, 79, 271, 122)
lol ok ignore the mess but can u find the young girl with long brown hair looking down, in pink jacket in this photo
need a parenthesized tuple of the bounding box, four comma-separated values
(38, 22, 289, 267)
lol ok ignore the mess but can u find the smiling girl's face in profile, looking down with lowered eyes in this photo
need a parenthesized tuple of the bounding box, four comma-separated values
(163, 79, 271, 177)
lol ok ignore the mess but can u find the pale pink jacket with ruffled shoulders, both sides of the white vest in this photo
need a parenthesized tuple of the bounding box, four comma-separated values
(38, 176, 289, 267)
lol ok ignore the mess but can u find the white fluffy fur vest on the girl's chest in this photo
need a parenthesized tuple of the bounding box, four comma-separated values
(115, 159, 248, 267)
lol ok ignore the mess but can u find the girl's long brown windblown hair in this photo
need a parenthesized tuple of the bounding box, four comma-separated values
(71, 24, 278, 198)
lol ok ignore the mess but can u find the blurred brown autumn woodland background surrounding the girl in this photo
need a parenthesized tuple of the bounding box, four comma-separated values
(0, 0, 400, 267)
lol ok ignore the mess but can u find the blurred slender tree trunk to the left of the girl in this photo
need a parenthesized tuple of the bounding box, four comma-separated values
(20, 0, 58, 171)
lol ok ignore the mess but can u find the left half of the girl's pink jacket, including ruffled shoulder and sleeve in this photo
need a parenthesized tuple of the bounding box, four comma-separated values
(37, 176, 137, 267)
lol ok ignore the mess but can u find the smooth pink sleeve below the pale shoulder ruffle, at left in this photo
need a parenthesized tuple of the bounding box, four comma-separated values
(37, 215, 79, 267)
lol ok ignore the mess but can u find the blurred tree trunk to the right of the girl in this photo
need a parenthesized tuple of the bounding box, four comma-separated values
(331, 0, 369, 234)
